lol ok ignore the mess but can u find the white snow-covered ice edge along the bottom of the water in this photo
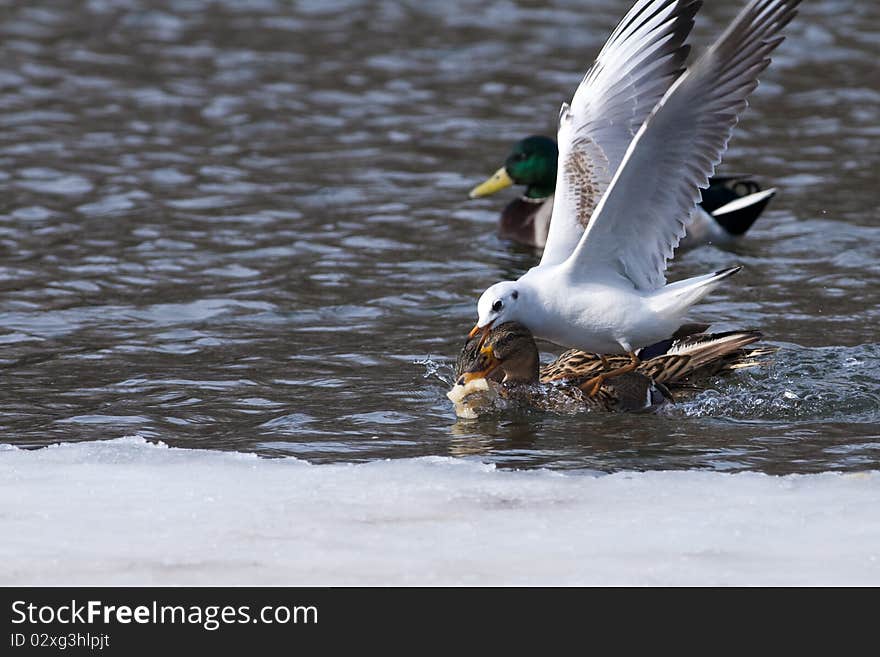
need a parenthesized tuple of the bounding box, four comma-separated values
(0, 437, 880, 586)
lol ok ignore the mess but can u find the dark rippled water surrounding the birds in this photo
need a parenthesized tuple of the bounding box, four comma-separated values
(0, 0, 880, 473)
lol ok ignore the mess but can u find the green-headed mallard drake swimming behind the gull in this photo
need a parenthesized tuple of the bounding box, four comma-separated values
(470, 135, 776, 249)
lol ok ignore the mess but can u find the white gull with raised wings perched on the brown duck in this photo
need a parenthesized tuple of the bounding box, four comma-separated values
(470, 0, 800, 391)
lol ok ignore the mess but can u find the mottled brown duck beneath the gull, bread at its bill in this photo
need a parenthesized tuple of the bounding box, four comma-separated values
(448, 322, 773, 418)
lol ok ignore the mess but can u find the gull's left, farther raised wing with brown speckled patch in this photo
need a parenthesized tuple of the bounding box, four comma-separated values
(541, 0, 702, 265)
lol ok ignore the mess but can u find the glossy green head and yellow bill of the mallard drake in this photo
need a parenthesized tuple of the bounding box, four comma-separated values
(470, 135, 559, 199)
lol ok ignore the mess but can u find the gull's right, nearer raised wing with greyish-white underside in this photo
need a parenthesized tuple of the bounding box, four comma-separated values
(567, 0, 800, 290)
